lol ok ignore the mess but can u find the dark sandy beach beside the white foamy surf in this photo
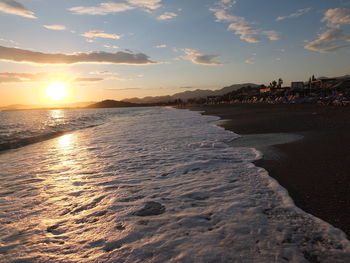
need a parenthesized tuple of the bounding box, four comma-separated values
(187, 104, 350, 237)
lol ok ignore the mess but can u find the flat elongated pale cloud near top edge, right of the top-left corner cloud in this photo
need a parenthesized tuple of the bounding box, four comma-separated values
(68, 2, 134, 15)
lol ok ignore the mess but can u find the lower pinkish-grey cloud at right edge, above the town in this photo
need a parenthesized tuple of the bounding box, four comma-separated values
(304, 28, 350, 53)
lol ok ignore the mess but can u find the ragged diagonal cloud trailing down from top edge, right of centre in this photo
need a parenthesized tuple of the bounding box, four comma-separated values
(209, 0, 279, 43)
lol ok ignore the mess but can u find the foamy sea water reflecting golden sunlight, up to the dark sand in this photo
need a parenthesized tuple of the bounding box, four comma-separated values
(0, 108, 350, 263)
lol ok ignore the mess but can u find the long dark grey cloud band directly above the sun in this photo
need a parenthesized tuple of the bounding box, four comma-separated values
(0, 46, 156, 65)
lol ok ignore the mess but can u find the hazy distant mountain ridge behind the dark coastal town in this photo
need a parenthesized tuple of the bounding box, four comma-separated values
(123, 83, 259, 103)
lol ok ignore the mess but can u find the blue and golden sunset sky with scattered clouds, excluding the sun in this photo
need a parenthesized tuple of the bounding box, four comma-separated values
(0, 0, 350, 106)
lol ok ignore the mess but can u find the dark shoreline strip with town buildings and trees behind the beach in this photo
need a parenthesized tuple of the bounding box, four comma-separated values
(191, 75, 350, 105)
